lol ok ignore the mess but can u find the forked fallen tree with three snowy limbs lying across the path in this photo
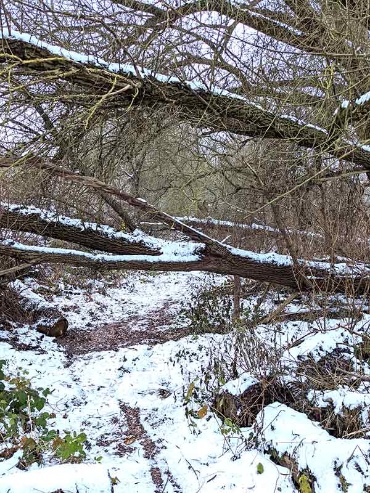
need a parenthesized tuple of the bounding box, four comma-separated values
(0, 188, 370, 293)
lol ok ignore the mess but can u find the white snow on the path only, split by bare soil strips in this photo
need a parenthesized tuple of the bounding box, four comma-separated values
(0, 274, 291, 493)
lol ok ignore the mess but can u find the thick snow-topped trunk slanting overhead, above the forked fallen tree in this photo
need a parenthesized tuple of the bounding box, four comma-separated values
(0, 29, 370, 169)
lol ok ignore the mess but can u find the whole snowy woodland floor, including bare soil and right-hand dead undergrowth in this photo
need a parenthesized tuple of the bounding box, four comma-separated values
(0, 273, 370, 493)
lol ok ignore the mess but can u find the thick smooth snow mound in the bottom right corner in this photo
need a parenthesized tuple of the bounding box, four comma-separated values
(257, 402, 370, 493)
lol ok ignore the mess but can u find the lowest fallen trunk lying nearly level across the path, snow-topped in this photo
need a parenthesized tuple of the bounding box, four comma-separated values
(0, 241, 370, 294)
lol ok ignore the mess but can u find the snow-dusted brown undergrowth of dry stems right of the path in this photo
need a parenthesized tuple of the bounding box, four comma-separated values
(184, 276, 370, 438)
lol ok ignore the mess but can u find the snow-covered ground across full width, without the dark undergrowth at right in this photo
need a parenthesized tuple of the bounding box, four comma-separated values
(0, 273, 370, 493)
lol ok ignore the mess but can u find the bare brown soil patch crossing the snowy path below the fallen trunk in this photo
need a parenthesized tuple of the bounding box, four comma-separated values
(57, 304, 191, 355)
